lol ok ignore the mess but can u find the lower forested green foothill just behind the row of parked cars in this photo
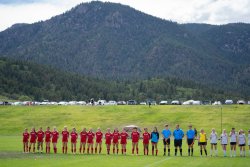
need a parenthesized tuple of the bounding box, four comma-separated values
(0, 58, 239, 101)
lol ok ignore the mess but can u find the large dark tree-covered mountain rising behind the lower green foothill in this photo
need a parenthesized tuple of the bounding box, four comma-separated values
(0, 2, 250, 94)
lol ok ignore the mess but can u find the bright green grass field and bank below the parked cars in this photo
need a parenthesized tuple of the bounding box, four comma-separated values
(0, 105, 250, 167)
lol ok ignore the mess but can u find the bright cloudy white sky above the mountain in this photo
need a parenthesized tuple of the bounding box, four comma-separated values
(0, 0, 250, 31)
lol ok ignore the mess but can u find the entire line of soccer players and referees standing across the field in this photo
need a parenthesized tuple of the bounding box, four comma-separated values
(23, 124, 250, 156)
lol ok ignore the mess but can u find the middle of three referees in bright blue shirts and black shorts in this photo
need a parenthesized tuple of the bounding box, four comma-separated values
(173, 124, 184, 156)
